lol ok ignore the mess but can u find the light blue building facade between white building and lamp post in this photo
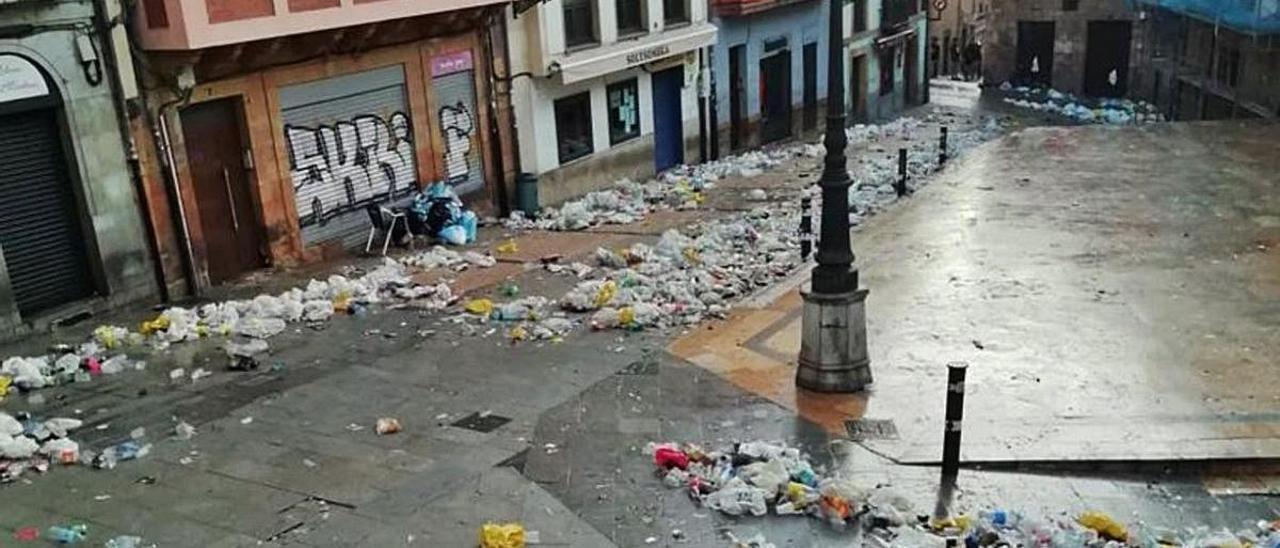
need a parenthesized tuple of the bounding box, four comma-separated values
(710, 0, 829, 154)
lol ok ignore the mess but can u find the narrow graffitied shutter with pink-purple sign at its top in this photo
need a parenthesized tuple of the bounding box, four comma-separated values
(431, 51, 484, 195)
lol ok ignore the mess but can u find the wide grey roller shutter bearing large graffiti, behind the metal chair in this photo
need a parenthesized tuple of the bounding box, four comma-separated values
(280, 65, 417, 247)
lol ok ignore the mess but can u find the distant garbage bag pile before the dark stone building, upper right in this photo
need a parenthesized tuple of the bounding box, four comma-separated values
(1000, 82, 1165, 125)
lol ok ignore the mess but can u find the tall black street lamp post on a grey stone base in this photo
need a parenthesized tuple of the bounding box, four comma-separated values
(796, 0, 872, 392)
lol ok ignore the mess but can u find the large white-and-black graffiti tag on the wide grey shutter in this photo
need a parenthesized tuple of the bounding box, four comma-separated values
(284, 113, 417, 227)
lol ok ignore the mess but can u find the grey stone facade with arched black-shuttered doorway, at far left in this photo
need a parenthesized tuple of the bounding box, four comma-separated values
(0, 1, 157, 339)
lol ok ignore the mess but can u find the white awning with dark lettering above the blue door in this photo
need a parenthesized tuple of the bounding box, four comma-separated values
(556, 23, 716, 83)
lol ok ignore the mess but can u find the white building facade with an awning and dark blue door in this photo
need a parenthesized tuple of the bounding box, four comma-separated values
(507, 0, 717, 204)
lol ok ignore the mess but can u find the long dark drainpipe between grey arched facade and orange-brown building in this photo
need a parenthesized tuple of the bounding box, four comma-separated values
(93, 0, 173, 302)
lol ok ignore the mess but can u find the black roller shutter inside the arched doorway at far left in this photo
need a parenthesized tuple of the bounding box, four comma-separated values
(0, 109, 95, 316)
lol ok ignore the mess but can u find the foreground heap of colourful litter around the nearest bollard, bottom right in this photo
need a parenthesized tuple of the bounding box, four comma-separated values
(643, 440, 1280, 548)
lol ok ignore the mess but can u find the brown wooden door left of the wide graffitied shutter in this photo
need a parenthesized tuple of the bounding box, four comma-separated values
(182, 99, 262, 283)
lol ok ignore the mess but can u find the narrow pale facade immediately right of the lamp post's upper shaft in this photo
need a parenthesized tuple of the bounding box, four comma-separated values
(845, 0, 928, 124)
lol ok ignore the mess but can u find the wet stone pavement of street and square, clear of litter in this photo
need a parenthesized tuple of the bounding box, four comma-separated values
(0, 85, 1280, 547)
